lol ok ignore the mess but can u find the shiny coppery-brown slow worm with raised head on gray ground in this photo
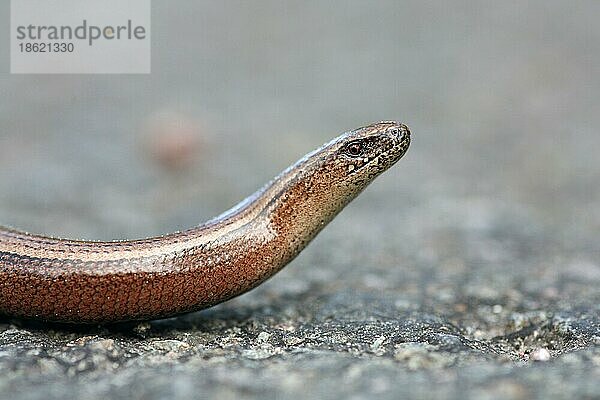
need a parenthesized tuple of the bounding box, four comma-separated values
(0, 121, 410, 323)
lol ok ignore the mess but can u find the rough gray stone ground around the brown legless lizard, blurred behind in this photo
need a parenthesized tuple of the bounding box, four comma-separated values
(0, 1, 600, 399)
